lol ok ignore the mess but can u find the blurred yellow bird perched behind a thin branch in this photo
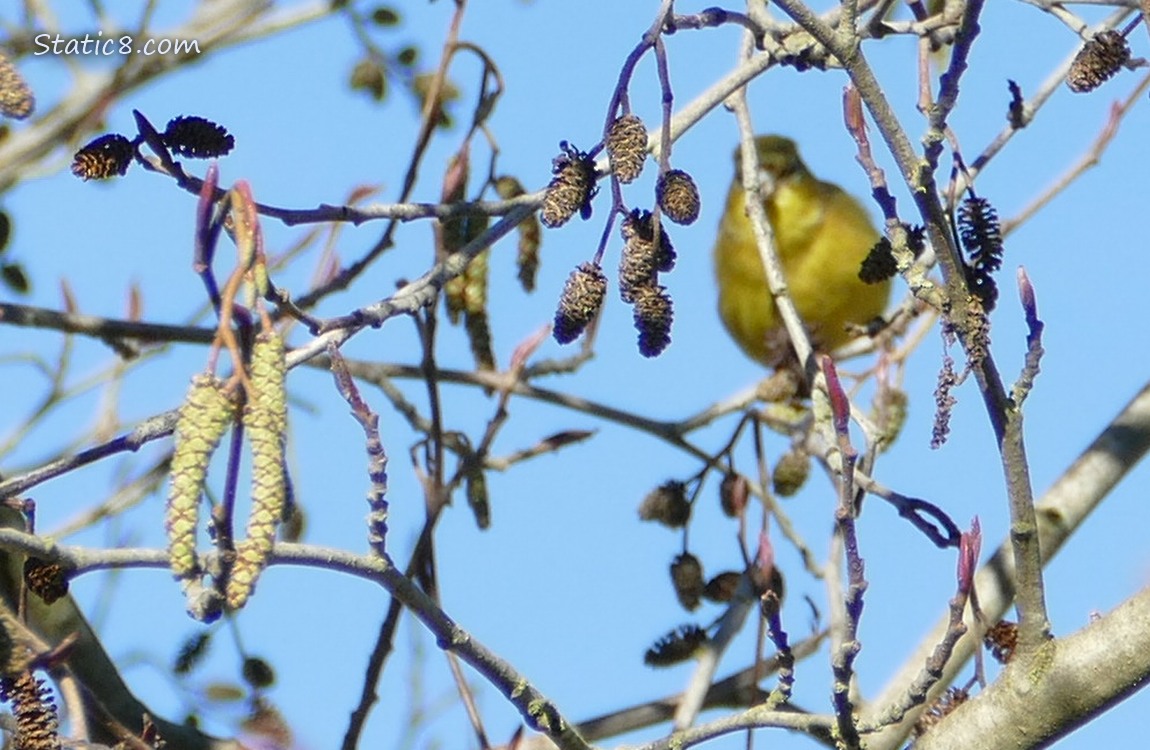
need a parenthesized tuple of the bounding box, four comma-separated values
(714, 136, 890, 367)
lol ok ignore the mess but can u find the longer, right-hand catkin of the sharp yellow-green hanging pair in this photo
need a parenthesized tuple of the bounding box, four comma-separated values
(225, 331, 288, 610)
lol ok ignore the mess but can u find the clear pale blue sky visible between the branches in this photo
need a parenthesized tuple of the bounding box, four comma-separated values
(0, 0, 1150, 749)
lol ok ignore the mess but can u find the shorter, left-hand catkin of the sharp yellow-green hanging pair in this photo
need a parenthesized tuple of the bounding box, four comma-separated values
(164, 374, 236, 579)
